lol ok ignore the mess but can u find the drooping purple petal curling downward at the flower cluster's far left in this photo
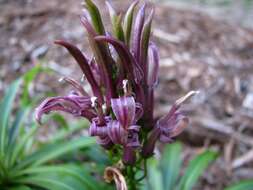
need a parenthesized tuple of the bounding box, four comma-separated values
(35, 94, 93, 123)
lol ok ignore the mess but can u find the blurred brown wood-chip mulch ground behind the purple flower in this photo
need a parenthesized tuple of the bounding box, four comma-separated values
(0, 0, 253, 189)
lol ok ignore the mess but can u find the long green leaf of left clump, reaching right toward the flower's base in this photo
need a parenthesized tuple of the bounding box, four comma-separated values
(17, 137, 96, 169)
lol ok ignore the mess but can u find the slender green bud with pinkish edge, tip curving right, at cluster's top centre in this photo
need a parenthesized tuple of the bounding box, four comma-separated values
(123, 1, 138, 47)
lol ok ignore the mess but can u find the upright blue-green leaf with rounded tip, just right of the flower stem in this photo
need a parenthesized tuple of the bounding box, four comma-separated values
(160, 143, 182, 189)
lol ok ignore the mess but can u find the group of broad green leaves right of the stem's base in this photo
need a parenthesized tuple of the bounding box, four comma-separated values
(144, 143, 217, 190)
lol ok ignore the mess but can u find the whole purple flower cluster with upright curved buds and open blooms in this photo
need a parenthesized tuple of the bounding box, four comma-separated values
(36, 0, 198, 165)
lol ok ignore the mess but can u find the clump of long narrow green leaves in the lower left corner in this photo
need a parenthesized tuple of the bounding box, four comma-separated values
(0, 73, 107, 190)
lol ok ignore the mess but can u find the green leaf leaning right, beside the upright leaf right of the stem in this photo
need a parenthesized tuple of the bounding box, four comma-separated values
(179, 151, 217, 190)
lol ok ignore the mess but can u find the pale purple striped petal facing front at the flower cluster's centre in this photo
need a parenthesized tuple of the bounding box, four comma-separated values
(111, 96, 136, 129)
